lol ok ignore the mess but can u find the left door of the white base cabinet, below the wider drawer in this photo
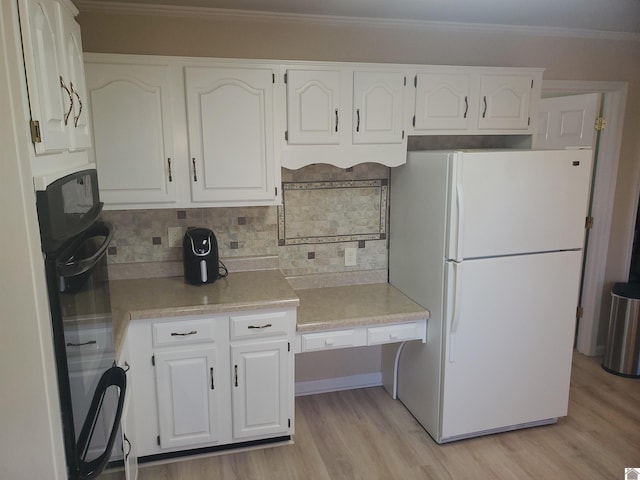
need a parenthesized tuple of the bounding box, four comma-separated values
(155, 346, 219, 448)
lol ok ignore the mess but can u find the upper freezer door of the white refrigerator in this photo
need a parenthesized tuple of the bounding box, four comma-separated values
(447, 150, 592, 261)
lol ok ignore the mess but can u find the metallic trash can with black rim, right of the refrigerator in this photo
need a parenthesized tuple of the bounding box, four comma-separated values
(602, 283, 640, 378)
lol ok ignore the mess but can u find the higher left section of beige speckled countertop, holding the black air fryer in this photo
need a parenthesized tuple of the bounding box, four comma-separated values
(109, 269, 299, 352)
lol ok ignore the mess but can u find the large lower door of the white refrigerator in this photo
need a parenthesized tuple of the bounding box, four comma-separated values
(436, 251, 582, 442)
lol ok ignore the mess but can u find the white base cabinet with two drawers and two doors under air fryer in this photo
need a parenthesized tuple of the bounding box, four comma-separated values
(128, 308, 296, 457)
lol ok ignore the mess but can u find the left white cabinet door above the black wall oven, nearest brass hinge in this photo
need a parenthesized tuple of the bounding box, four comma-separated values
(18, 0, 71, 153)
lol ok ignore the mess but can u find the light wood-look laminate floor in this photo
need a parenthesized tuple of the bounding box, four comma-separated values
(131, 354, 640, 480)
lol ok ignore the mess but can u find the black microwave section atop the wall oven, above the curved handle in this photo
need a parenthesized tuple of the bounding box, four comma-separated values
(36, 168, 103, 252)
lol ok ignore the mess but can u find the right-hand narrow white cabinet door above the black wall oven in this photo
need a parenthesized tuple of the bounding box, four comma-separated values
(56, 4, 91, 151)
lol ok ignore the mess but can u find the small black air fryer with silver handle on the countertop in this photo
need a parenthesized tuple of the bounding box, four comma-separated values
(182, 228, 220, 285)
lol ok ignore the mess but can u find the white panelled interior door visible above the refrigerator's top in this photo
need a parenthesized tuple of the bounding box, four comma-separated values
(533, 93, 600, 149)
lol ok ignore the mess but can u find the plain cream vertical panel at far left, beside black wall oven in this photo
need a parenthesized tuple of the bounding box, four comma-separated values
(0, 0, 67, 480)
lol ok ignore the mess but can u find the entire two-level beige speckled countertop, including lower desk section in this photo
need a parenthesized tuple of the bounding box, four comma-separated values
(109, 269, 429, 352)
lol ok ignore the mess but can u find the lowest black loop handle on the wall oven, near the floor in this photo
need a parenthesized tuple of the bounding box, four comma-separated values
(77, 367, 127, 480)
